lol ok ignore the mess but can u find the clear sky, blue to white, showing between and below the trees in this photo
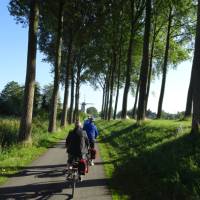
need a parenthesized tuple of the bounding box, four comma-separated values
(0, 0, 192, 113)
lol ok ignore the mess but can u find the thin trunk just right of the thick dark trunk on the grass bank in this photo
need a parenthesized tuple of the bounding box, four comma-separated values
(145, 24, 156, 112)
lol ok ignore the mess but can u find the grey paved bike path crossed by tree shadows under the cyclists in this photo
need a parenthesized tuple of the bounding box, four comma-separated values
(0, 141, 112, 200)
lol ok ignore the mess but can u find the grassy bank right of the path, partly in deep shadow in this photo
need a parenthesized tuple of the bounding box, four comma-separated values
(97, 120, 200, 200)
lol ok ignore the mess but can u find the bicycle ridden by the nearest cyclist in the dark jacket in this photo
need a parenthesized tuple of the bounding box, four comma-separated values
(66, 161, 80, 198)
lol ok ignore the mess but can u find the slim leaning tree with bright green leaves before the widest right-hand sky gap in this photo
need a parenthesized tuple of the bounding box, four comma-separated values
(157, 0, 193, 118)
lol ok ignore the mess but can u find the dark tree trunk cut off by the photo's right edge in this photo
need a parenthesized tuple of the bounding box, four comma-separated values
(191, 0, 200, 135)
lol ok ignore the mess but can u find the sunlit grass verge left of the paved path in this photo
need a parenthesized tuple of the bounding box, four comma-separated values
(0, 117, 71, 184)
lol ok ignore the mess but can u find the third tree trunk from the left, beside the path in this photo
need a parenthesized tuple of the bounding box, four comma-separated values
(61, 34, 72, 127)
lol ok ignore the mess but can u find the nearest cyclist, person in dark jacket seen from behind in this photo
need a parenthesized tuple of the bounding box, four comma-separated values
(65, 121, 89, 180)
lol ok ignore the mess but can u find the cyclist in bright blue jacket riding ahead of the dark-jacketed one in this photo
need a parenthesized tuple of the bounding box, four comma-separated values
(83, 117, 98, 165)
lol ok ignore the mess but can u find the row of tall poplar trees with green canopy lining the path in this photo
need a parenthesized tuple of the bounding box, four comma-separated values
(8, 0, 200, 144)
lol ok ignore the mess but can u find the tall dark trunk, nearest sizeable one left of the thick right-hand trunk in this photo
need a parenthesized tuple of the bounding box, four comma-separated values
(121, 0, 134, 119)
